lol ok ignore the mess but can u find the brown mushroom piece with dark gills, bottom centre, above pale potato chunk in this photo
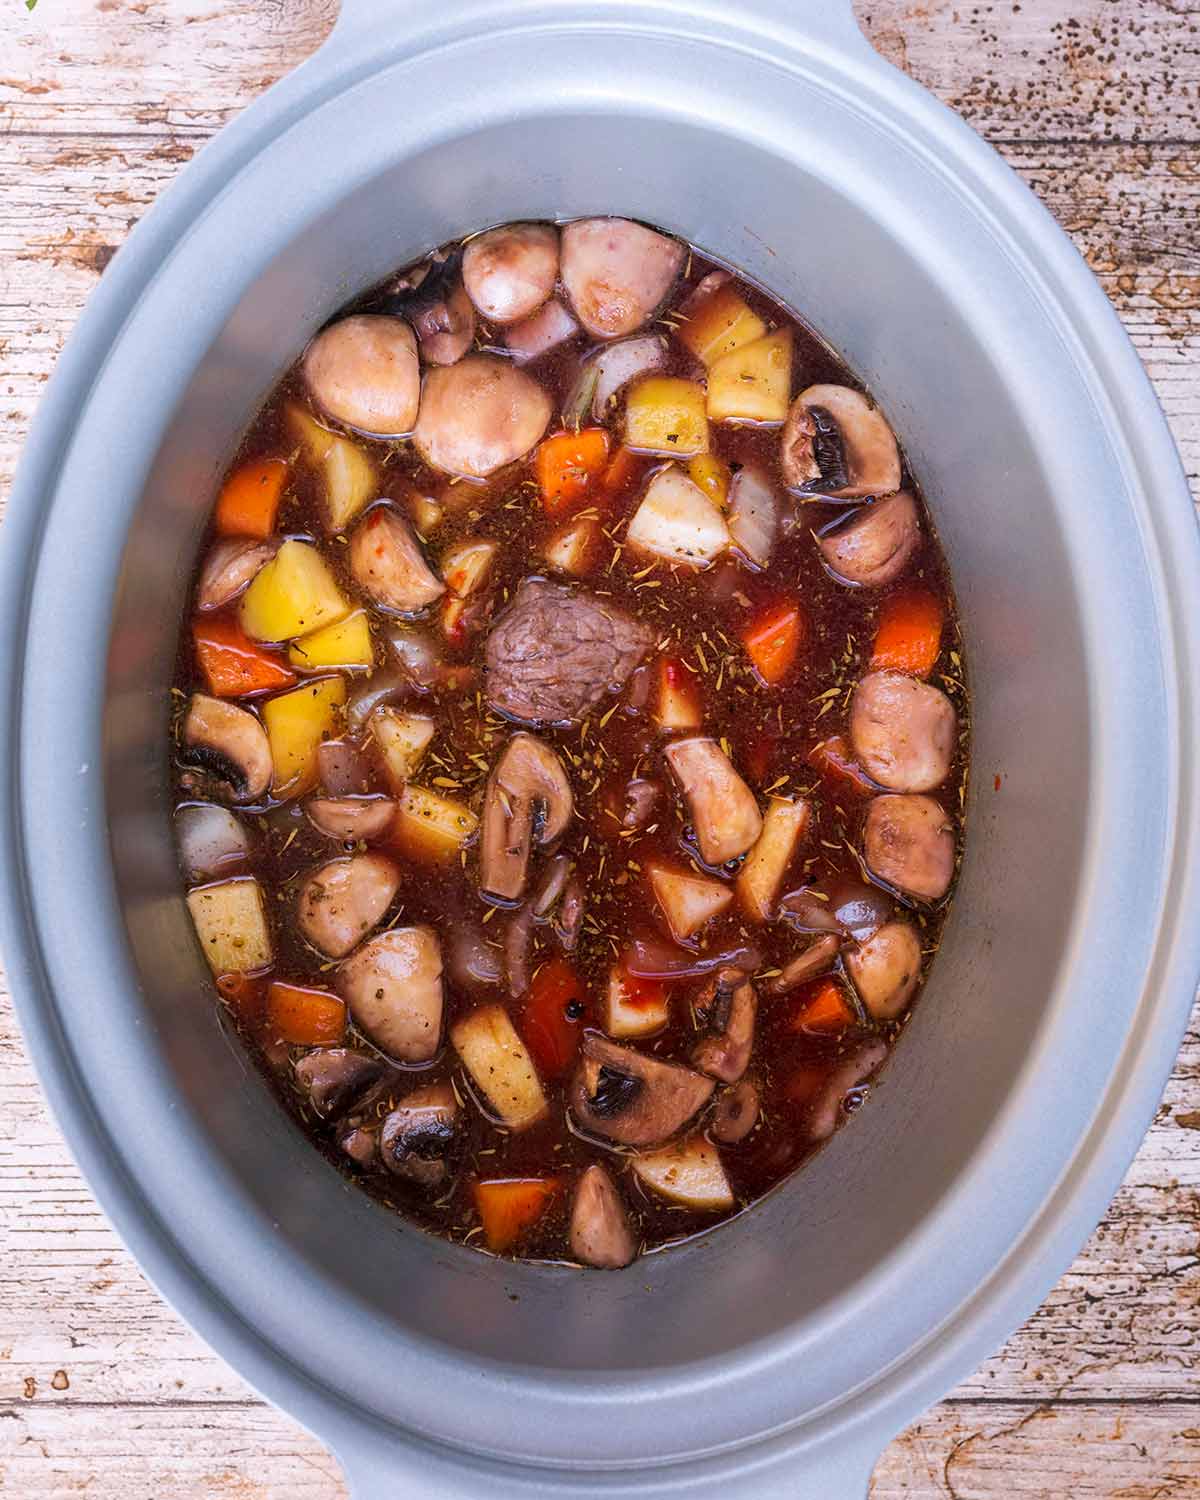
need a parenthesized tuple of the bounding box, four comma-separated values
(567, 1032, 716, 1146)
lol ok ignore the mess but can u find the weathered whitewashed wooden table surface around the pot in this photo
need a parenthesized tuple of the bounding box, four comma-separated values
(0, 0, 1200, 1500)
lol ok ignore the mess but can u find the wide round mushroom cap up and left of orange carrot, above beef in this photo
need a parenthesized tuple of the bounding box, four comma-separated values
(413, 354, 554, 479)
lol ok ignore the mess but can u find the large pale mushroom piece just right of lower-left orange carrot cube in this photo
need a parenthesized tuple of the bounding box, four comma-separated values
(335, 927, 443, 1062)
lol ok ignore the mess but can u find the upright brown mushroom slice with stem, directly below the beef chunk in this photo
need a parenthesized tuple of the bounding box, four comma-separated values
(480, 731, 575, 902)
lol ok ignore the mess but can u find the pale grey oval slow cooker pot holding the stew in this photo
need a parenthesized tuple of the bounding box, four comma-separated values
(0, 0, 1200, 1500)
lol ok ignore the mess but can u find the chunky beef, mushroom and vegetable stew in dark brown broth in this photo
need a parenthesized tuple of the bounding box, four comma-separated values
(173, 219, 968, 1268)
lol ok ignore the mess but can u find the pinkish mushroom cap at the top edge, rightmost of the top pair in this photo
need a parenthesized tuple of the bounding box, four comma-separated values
(563, 219, 684, 339)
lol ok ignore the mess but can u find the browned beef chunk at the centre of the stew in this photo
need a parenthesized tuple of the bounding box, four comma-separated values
(486, 578, 653, 725)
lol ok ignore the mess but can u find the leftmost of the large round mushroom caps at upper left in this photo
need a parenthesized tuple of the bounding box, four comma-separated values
(302, 314, 420, 438)
